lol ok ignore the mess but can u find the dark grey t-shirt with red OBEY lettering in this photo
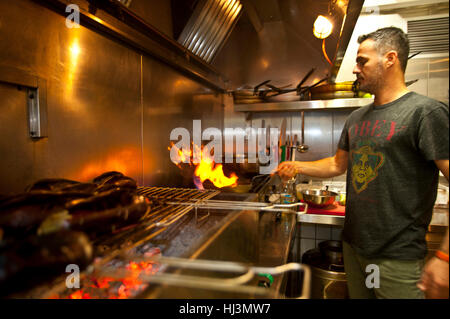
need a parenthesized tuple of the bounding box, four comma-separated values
(338, 92, 449, 260)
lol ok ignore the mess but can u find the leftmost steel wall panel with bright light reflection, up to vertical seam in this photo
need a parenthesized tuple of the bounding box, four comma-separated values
(0, 1, 142, 192)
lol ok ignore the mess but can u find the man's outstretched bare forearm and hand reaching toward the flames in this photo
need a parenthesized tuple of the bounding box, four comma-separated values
(275, 149, 348, 179)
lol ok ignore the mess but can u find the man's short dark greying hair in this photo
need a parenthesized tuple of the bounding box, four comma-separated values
(358, 27, 409, 73)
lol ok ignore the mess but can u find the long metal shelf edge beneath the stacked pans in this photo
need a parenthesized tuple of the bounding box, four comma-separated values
(234, 98, 373, 112)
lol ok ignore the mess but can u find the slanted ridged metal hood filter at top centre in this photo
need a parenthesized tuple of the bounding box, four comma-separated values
(178, 0, 242, 63)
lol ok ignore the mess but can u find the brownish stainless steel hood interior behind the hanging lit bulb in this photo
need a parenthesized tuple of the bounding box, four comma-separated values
(212, 0, 364, 90)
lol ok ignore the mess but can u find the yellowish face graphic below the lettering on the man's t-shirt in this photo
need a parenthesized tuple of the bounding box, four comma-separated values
(350, 140, 384, 194)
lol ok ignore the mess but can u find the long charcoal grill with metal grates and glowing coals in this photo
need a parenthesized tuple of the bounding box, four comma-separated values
(1, 173, 310, 299)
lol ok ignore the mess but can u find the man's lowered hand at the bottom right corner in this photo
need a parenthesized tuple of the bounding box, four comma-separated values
(417, 257, 449, 299)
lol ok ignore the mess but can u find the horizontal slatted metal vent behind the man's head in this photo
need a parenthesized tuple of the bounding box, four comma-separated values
(408, 17, 448, 53)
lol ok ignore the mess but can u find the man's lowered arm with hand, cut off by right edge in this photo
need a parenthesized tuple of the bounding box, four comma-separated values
(417, 160, 449, 299)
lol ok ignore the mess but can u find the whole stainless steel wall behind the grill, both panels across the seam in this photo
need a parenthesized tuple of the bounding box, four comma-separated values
(0, 0, 223, 194)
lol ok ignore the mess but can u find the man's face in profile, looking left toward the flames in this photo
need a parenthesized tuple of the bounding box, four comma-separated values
(353, 39, 383, 94)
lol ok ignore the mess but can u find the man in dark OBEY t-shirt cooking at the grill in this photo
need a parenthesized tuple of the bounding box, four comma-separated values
(277, 27, 449, 298)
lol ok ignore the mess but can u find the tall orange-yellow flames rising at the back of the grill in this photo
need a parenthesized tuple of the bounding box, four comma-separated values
(168, 143, 238, 189)
